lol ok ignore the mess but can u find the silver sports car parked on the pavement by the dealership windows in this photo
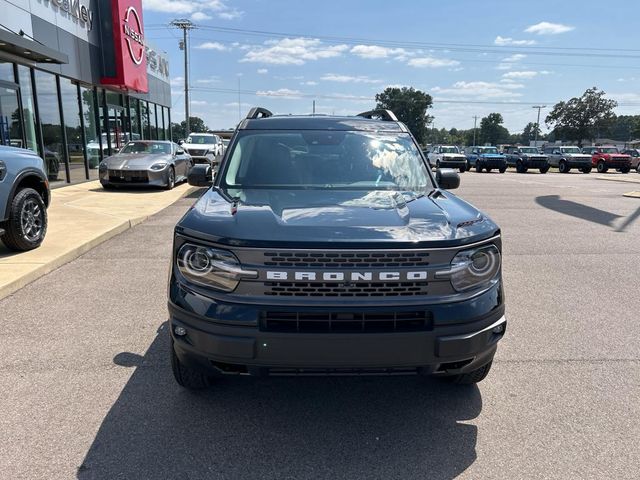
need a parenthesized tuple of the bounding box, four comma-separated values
(98, 140, 193, 190)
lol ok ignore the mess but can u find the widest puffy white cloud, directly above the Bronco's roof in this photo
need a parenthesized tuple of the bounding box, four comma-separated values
(240, 37, 349, 65)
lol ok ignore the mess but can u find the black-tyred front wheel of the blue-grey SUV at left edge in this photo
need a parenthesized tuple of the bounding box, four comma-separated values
(2, 188, 47, 252)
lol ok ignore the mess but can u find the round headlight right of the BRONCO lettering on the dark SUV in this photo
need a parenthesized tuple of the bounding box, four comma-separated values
(436, 245, 501, 292)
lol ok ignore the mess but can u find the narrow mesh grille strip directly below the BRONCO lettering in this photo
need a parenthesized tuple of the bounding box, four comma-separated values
(264, 282, 428, 297)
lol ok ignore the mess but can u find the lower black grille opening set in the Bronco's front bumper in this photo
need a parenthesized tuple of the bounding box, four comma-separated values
(260, 311, 433, 333)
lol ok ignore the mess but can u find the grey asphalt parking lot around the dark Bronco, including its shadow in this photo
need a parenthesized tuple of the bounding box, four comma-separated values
(0, 171, 640, 479)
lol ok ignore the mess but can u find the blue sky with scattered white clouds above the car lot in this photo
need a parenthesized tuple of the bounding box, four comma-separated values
(142, 0, 640, 132)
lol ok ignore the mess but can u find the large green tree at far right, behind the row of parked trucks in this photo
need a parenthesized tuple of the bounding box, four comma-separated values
(545, 87, 618, 145)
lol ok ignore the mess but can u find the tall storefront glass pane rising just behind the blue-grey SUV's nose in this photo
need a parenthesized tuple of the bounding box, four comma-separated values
(35, 70, 66, 182)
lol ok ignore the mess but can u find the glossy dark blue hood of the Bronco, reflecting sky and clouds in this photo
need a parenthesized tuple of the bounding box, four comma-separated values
(176, 189, 498, 248)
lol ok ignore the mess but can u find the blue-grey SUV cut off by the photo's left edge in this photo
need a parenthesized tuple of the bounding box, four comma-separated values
(0, 146, 50, 251)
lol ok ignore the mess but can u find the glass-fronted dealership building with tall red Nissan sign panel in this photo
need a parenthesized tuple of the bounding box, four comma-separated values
(0, 0, 171, 186)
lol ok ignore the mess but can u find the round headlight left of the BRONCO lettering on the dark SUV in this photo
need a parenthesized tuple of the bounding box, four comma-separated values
(177, 243, 258, 292)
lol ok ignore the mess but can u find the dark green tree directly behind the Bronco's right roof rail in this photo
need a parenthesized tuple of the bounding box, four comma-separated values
(376, 87, 433, 144)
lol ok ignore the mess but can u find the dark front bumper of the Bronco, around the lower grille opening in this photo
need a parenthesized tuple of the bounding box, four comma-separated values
(169, 283, 506, 375)
